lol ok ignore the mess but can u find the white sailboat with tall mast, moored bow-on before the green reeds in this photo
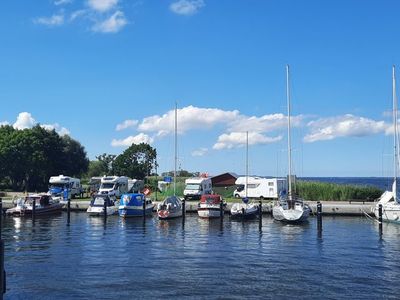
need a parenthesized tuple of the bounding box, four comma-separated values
(272, 65, 311, 223)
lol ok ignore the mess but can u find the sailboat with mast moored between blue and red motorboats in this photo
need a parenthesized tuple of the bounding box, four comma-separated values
(157, 104, 183, 220)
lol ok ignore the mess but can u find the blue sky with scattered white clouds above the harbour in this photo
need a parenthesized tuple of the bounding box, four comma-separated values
(0, 0, 400, 176)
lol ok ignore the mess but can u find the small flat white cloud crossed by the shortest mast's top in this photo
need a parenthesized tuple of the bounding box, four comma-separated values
(213, 132, 282, 150)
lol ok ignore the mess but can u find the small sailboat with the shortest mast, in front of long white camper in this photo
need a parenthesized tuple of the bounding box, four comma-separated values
(231, 131, 259, 220)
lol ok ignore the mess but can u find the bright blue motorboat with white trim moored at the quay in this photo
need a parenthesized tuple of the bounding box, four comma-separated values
(118, 193, 154, 217)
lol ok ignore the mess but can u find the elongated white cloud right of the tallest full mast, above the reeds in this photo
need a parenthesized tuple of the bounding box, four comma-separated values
(304, 114, 388, 143)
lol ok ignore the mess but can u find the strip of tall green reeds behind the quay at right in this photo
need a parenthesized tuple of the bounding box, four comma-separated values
(296, 181, 382, 201)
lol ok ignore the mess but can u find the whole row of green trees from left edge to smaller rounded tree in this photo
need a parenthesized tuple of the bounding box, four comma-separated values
(0, 125, 157, 191)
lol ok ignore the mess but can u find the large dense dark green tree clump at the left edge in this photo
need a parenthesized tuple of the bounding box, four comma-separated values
(0, 125, 89, 191)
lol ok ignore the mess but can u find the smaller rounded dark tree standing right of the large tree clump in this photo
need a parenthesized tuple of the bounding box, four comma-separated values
(113, 143, 157, 179)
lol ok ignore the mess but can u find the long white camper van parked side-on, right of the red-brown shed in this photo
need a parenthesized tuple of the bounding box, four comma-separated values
(233, 176, 286, 199)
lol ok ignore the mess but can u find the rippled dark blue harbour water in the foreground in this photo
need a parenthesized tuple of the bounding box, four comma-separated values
(3, 213, 400, 299)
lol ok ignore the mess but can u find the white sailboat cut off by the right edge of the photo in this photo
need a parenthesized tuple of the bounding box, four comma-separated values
(374, 66, 400, 223)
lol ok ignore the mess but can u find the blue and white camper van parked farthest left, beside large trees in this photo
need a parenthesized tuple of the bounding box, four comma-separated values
(48, 175, 83, 201)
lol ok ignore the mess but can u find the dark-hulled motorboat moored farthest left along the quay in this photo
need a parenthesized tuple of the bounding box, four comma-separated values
(6, 194, 64, 216)
